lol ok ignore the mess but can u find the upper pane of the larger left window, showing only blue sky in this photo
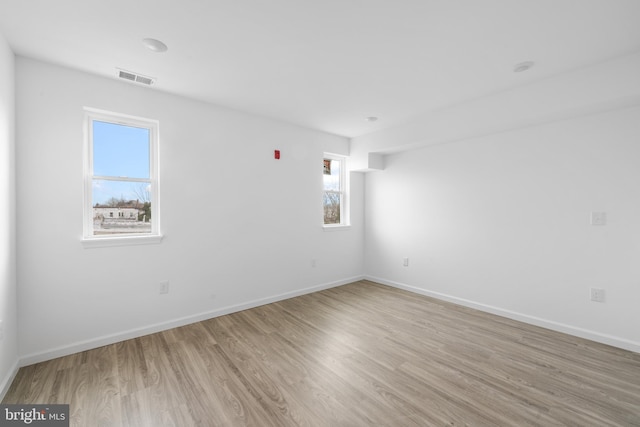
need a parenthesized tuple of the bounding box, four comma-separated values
(93, 120, 150, 178)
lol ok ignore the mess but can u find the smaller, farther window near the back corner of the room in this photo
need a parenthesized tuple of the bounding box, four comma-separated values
(322, 154, 348, 226)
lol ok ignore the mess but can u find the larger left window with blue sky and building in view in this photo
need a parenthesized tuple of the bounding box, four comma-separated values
(84, 108, 160, 243)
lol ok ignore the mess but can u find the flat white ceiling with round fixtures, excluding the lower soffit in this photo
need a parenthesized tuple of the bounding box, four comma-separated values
(0, 0, 640, 137)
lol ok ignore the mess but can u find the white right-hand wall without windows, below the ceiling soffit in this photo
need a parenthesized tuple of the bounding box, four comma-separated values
(365, 107, 640, 351)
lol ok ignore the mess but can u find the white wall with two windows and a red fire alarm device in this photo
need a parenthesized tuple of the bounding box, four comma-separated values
(16, 58, 363, 363)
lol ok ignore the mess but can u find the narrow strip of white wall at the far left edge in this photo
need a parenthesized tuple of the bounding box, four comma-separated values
(0, 34, 18, 400)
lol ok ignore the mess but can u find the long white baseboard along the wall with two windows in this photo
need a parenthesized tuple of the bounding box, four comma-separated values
(20, 276, 364, 368)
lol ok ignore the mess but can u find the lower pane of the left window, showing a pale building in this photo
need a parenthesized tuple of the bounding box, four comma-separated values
(92, 179, 152, 236)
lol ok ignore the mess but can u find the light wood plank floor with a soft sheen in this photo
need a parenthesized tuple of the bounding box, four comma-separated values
(3, 281, 640, 427)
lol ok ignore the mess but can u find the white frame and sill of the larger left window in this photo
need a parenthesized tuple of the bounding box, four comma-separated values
(82, 107, 162, 248)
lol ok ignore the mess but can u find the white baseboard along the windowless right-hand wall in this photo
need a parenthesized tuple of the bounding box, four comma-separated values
(365, 276, 640, 353)
